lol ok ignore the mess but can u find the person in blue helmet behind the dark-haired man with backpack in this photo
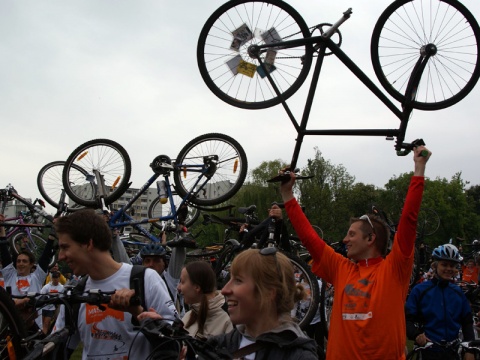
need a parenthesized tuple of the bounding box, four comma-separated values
(139, 240, 186, 315)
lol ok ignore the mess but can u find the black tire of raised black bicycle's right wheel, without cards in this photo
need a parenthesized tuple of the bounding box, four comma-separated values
(370, 0, 480, 110)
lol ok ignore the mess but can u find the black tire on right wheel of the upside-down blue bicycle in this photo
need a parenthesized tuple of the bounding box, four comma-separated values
(173, 133, 248, 205)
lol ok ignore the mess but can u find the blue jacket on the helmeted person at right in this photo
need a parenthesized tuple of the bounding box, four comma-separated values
(405, 278, 475, 342)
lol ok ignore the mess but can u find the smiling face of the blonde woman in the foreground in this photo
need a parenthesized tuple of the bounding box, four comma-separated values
(222, 272, 262, 327)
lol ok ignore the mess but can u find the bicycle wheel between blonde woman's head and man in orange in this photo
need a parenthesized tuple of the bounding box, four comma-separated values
(282, 251, 320, 329)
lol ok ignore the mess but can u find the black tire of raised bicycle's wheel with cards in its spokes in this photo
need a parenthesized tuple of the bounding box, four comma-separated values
(197, 0, 313, 109)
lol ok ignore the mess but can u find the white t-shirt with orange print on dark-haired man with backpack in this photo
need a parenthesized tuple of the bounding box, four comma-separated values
(64, 263, 175, 360)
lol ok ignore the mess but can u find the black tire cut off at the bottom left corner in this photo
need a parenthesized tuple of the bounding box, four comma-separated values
(0, 287, 26, 359)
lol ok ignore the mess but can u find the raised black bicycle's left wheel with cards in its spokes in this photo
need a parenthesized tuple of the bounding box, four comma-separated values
(197, 0, 313, 109)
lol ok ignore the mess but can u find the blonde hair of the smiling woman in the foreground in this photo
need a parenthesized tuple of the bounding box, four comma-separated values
(230, 249, 306, 315)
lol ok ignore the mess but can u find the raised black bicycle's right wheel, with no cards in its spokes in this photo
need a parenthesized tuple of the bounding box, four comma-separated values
(370, 0, 480, 110)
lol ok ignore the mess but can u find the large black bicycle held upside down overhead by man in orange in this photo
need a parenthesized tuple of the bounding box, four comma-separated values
(197, 0, 480, 169)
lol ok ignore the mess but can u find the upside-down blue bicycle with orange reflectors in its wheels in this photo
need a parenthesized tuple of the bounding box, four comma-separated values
(62, 133, 247, 245)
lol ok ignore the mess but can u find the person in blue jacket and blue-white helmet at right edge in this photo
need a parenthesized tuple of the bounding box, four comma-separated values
(405, 244, 475, 360)
